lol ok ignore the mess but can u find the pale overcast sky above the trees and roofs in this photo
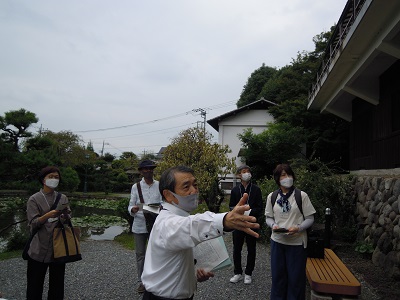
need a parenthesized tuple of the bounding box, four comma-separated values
(0, 0, 347, 157)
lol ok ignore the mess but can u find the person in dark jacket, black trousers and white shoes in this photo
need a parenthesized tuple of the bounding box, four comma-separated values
(229, 165, 263, 284)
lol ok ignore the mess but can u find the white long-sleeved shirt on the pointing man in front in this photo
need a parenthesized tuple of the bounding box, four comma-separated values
(142, 202, 226, 299)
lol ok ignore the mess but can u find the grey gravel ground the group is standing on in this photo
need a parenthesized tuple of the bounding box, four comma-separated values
(0, 233, 379, 300)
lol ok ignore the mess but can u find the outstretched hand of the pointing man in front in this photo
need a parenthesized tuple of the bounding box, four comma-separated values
(224, 193, 260, 238)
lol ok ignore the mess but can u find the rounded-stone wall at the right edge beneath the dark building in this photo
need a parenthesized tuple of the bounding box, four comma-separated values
(353, 176, 400, 279)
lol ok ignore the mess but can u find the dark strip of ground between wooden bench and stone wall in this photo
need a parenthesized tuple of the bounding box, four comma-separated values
(332, 242, 400, 300)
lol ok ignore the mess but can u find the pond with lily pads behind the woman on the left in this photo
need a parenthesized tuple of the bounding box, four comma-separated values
(0, 197, 129, 252)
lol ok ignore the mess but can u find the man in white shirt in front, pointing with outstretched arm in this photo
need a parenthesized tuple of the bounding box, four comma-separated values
(142, 166, 260, 300)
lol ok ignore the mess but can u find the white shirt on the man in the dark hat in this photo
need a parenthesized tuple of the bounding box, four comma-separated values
(128, 178, 162, 233)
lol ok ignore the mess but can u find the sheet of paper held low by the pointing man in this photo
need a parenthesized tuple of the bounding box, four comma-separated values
(193, 236, 232, 272)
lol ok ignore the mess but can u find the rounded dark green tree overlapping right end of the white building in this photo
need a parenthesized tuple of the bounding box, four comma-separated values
(239, 123, 305, 179)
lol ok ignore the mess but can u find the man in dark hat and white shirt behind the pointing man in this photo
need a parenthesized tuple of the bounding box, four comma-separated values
(128, 160, 162, 293)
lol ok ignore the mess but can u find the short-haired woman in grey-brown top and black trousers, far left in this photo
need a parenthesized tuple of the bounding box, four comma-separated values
(26, 166, 71, 300)
